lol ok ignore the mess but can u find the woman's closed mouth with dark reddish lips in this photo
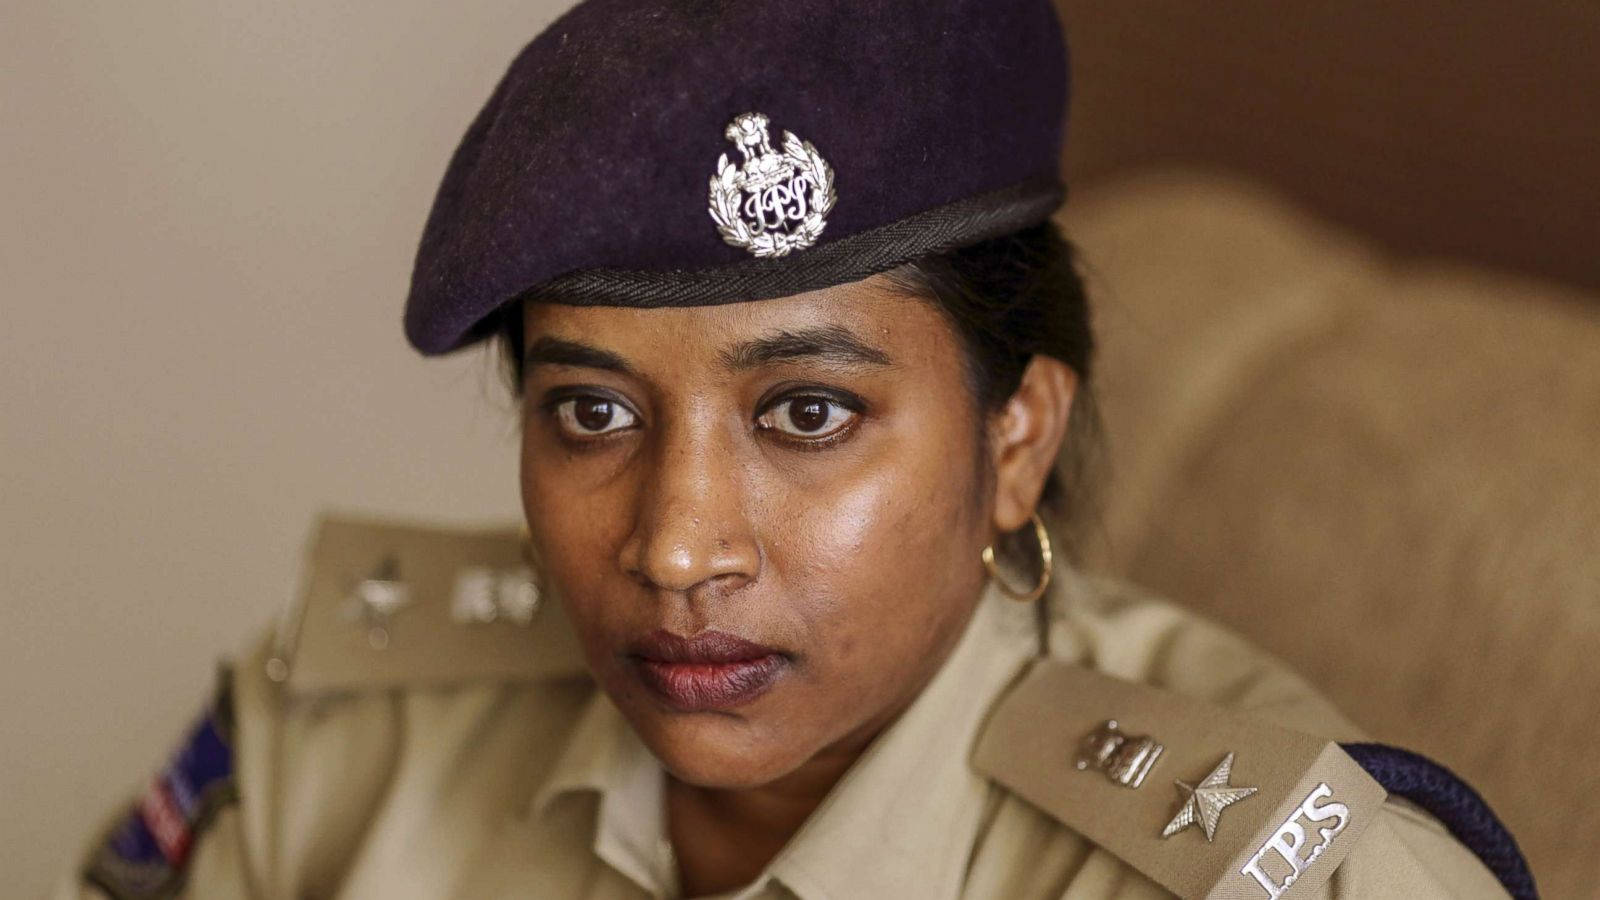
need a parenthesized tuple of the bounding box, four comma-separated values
(626, 631, 790, 713)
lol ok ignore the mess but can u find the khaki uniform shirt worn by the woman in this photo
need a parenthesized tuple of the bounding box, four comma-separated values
(58, 515, 1504, 900)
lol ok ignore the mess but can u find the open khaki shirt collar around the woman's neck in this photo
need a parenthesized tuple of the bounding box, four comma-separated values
(533, 588, 1038, 900)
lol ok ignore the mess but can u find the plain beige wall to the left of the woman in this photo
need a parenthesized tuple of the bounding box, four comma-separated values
(0, 0, 565, 897)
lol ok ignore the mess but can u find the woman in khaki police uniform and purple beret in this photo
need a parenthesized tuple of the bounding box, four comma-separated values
(64, 0, 1531, 898)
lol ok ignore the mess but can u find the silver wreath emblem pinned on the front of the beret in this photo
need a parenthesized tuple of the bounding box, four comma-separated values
(710, 112, 838, 258)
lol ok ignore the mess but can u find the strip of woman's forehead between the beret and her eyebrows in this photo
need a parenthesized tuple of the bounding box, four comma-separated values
(523, 275, 957, 365)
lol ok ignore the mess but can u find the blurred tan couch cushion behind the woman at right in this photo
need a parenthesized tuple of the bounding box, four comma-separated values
(1066, 173, 1600, 895)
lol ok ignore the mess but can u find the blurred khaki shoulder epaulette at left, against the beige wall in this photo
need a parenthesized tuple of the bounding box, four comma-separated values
(266, 516, 584, 692)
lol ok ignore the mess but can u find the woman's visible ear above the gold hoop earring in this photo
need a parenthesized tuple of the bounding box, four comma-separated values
(989, 356, 1078, 533)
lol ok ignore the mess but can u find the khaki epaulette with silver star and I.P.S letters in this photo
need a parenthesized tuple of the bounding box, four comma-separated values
(973, 660, 1387, 900)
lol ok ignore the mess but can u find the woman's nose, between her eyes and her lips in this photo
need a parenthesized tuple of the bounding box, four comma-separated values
(618, 416, 762, 594)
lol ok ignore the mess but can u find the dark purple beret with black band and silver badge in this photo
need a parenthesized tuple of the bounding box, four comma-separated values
(405, 0, 1067, 354)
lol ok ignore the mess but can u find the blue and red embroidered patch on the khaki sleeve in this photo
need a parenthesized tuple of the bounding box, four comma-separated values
(83, 668, 237, 900)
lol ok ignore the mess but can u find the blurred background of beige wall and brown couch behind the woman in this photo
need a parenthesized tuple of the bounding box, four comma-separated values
(0, 0, 1600, 897)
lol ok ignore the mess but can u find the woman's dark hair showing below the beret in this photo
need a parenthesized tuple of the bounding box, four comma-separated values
(496, 221, 1099, 556)
